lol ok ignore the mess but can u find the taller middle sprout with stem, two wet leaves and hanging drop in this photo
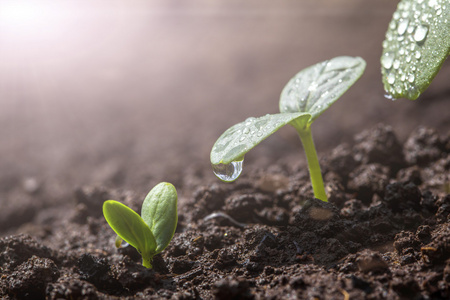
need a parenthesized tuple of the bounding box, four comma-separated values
(210, 56, 366, 202)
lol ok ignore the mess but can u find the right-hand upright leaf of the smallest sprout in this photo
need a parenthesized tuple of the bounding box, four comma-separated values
(141, 182, 178, 253)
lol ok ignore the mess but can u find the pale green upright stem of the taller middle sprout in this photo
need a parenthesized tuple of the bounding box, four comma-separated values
(297, 126, 328, 202)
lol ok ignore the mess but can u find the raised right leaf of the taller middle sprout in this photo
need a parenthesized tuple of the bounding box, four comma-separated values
(280, 56, 366, 122)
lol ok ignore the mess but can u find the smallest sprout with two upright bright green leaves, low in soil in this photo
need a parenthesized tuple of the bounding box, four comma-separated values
(103, 182, 178, 268)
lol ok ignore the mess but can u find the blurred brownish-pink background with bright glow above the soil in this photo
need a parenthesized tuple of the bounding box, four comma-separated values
(0, 0, 450, 211)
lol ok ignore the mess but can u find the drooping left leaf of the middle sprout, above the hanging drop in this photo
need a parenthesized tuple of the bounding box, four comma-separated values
(210, 112, 311, 165)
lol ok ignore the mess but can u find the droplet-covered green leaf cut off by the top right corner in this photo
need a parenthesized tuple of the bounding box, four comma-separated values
(381, 0, 450, 100)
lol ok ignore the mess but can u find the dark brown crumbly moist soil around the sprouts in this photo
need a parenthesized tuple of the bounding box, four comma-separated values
(0, 125, 450, 299)
